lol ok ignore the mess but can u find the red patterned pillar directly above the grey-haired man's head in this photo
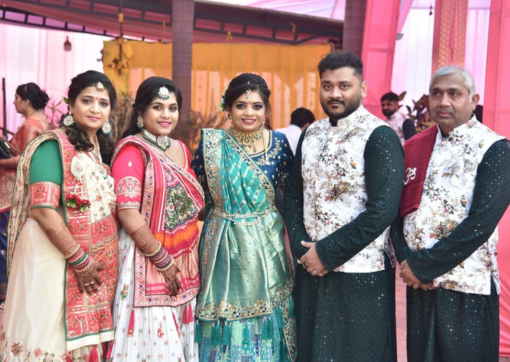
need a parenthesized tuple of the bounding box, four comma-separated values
(432, 0, 468, 74)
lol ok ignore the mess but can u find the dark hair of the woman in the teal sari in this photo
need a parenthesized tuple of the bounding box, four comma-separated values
(224, 73, 271, 117)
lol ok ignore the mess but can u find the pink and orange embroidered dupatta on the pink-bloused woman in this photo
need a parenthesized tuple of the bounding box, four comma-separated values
(112, 136, 204, 307)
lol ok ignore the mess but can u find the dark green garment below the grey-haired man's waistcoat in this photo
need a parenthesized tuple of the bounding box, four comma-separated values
(407, 283, 499, 362)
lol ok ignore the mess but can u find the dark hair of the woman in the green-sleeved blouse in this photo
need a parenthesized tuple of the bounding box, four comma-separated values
(60, 70, 117, 165)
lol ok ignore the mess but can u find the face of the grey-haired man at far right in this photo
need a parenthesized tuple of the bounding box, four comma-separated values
(429, 73, 480, 135)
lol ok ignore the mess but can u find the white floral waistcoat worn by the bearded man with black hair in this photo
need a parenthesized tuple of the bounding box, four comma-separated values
(301, 106, 394, 273)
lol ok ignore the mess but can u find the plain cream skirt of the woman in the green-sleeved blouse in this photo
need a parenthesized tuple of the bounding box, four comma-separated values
(0, 219, 105, 362)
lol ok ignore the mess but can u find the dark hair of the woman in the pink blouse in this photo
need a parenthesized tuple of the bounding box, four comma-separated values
(122, 77, 182, 138)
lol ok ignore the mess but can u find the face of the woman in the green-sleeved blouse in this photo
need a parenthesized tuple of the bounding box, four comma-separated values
(69, 87, 111, 134)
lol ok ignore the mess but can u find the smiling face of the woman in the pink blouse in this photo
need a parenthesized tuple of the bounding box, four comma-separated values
(142, 93, 179, 136)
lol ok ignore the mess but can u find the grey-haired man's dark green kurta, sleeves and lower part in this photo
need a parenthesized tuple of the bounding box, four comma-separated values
(391, 140, 510, 362)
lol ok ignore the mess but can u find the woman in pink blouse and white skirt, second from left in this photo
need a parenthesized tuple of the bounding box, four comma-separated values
(112, 77, 204, 362)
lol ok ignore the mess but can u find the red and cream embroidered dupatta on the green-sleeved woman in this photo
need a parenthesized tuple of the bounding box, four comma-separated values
(7, 129, 118, 351)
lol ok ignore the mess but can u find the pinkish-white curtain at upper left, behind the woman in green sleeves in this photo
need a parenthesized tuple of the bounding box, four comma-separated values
(0, 23, 109, 132)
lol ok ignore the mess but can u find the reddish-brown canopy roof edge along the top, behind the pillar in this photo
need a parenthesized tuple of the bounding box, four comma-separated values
(0, 0, 343, 45)
